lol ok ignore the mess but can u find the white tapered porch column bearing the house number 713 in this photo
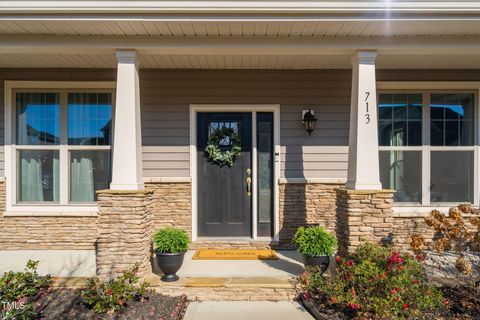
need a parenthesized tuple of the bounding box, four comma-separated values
(346, 51, 382, 190)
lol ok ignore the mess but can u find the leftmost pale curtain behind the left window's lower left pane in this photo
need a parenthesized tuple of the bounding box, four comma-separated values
(20, 153, 44, 201)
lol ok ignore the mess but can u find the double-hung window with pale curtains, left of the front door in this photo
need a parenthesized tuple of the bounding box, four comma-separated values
(11, 89, 113, 206)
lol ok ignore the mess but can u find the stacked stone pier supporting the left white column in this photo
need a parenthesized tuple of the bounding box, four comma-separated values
(97, 190, 153, 279)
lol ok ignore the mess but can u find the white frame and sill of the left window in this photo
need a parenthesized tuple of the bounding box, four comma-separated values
(4, 81, 116, 216)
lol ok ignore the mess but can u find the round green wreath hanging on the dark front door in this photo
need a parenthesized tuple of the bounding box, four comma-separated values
(205, 127, 242, 167)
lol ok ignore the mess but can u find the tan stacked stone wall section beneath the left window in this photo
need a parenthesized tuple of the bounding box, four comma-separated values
(0, 181, 98, 250)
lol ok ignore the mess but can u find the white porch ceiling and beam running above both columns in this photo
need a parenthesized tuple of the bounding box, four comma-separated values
(0, 14, 480, 69)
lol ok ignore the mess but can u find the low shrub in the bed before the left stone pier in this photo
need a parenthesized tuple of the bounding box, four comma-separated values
(82, 264, 148, 313)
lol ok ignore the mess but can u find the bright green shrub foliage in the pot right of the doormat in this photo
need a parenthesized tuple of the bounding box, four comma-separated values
(292, 226, 337, 256)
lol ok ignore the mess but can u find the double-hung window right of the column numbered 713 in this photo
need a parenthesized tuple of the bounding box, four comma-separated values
(378, 90, 477, 205)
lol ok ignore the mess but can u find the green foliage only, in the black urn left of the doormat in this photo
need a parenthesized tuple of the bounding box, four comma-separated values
(153, 228, 190, 253)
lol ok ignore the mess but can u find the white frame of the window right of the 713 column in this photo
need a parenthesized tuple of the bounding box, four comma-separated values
(377, 81, 480, 213)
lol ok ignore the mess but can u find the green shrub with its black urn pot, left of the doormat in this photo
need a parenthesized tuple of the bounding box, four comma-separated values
(153, 228, 190, 282)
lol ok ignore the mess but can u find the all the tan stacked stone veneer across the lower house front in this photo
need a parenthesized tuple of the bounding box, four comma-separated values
(4, 175, 472, 277)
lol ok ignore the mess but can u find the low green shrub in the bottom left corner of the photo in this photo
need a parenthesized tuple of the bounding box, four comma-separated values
(0, 260, 52, 320)
